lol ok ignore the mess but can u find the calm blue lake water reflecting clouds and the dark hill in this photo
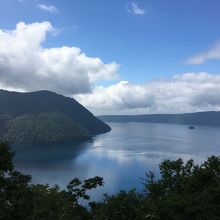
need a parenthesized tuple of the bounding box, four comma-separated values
(14, 123, 220, 198)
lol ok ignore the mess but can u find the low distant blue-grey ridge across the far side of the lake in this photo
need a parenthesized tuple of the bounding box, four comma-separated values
(98, 111, 220, 126)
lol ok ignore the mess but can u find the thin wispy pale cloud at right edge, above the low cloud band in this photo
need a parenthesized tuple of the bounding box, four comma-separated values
(186, 42, 220, 64)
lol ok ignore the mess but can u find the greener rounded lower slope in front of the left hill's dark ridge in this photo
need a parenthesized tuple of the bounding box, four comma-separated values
(0, 112, 90, 144)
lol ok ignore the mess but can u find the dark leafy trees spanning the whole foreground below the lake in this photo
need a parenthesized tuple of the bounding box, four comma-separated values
(0, 144, 220, 220)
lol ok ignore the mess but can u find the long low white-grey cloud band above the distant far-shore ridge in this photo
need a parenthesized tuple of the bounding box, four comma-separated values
(75, 73, 220, 114)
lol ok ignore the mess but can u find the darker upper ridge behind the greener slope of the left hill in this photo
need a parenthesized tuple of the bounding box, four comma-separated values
(0, 90, 110, 134)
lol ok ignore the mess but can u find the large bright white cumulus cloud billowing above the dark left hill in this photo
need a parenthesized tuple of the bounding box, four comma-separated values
(0, 22, 119, 95)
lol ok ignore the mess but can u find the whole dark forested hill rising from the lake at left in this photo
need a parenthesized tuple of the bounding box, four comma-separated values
(0, 90, 111, 143)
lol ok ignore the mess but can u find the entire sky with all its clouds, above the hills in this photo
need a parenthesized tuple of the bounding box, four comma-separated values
(0, 0, 220, 115)
